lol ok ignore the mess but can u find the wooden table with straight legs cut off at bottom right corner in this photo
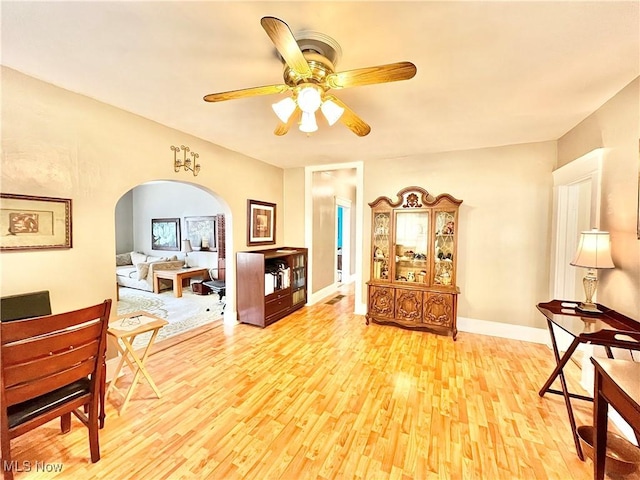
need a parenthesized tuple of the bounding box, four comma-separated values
(591, 358, 640, 480)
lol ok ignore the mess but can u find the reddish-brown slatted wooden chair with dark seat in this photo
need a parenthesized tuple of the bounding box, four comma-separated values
(0, 299, 111, 480)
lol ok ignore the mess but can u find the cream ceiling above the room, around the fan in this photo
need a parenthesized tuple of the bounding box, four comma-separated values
(1, 0, 640, 167)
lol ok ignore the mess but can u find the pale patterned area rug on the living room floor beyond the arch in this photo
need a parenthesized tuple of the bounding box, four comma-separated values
(118, 287, 223, 348)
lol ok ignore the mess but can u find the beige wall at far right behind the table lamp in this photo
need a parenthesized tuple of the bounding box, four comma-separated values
(558, 78, 640, 320)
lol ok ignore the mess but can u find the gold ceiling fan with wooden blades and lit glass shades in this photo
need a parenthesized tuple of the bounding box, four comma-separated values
(204, 17, 416, 137)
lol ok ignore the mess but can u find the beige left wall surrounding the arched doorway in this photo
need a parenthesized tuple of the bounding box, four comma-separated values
(0, 68, 284, 311)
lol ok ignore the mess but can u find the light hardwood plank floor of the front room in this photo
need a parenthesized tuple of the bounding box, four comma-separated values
(6, 289, 616, 480)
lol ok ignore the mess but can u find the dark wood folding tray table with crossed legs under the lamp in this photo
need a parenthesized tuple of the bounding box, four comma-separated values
(537, 300, 640, 460)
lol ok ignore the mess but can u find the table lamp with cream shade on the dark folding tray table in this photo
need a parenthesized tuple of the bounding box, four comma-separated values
(571, 228, 615, 313)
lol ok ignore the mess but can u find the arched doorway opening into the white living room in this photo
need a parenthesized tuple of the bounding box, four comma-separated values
(114, 181, 235, 340)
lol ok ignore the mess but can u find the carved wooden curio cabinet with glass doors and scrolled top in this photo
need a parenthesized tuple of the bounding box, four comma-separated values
(367, 187, 462, 340)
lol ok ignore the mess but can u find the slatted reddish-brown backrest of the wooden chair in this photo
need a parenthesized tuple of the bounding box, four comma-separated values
(0, 299, 111, 408)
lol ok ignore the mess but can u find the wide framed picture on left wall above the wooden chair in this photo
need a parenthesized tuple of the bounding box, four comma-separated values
(0, 193, 71, 251)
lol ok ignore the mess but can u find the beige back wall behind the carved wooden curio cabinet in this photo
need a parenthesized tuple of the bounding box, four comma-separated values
(363, 142, 556, 328)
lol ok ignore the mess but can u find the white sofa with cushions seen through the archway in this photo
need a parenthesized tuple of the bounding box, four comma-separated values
(116, 252, 184, 292)
